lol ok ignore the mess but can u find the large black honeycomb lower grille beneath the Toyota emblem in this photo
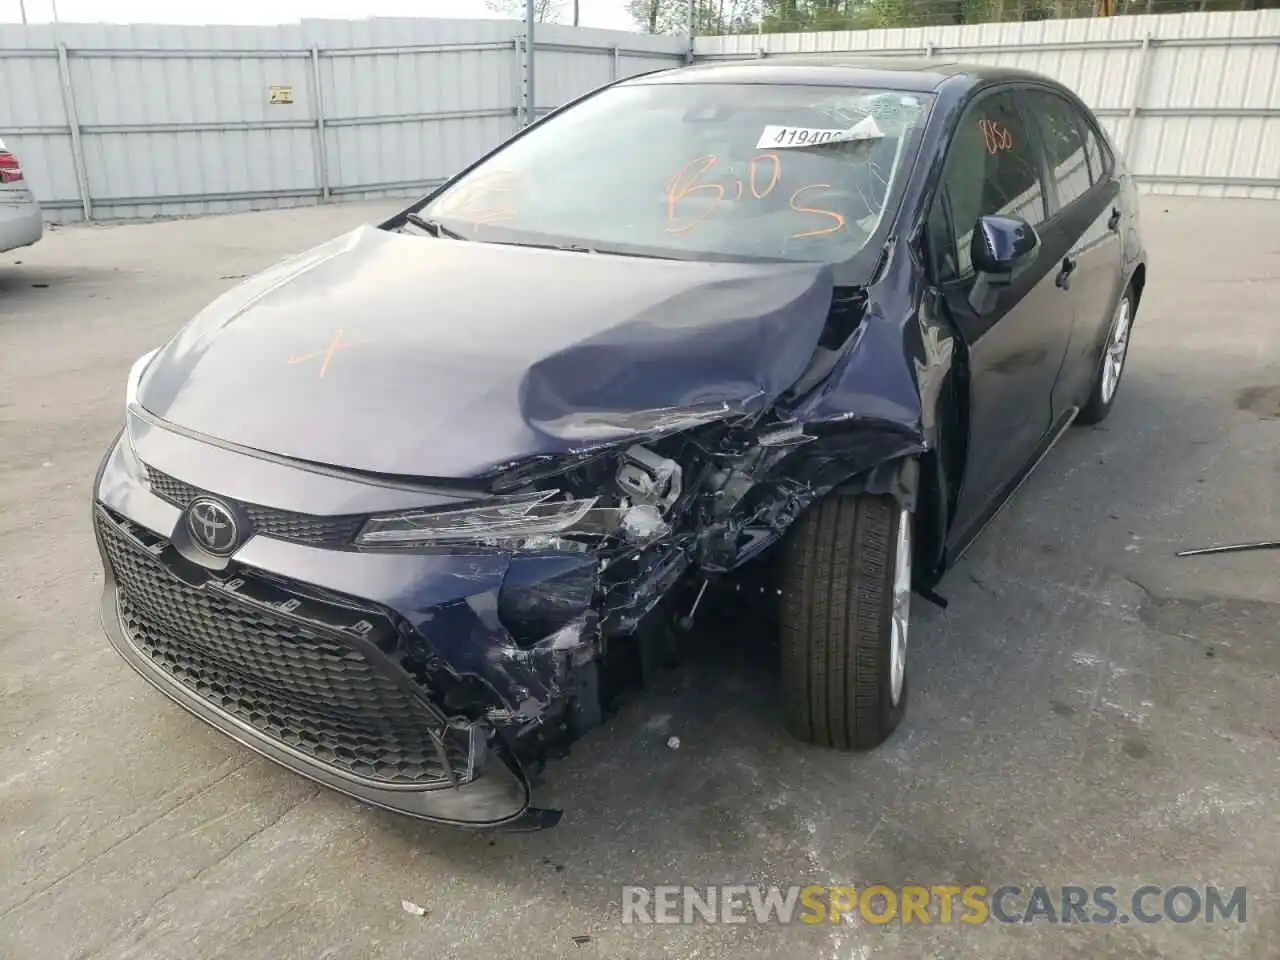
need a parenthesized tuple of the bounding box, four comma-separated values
(97, 509, 468, 786)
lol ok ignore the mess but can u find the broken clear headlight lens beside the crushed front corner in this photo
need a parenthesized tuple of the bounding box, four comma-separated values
(356, 490, 599, 547)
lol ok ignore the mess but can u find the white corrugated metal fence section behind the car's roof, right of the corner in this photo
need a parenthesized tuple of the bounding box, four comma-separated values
(695, 10, 1280, 198)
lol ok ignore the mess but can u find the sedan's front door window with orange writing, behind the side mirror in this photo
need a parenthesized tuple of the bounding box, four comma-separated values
(931, 92, 1044, 279)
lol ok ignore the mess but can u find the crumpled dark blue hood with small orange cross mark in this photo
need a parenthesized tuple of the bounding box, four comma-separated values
(138, 227, 832, 477)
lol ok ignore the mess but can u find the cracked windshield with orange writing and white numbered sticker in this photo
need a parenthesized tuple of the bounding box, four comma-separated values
(422, 83, 931, 262)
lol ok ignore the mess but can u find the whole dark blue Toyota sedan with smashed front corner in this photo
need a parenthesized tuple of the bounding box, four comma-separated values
(93, 58, 1147, 828)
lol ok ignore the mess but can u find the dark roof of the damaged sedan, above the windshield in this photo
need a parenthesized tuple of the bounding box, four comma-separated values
(623, 54, 1048, 93)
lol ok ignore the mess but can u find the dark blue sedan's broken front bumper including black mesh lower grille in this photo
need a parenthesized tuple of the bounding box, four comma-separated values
(93, 425, 601, 829)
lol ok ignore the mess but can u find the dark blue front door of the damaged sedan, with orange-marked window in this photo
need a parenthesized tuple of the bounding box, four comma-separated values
(929, 88, 1074, 544)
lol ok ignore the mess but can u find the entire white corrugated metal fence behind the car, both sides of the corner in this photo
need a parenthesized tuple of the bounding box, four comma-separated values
(0, 10, 1280, 220)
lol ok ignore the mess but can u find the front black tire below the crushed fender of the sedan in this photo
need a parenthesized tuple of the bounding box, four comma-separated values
(780, 494, 911, 750)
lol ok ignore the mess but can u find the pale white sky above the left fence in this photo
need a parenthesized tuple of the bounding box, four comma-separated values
(0, 0, 635, 29)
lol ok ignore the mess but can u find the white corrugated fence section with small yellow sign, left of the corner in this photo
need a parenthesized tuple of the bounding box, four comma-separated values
(0, 19, 687, 220)
